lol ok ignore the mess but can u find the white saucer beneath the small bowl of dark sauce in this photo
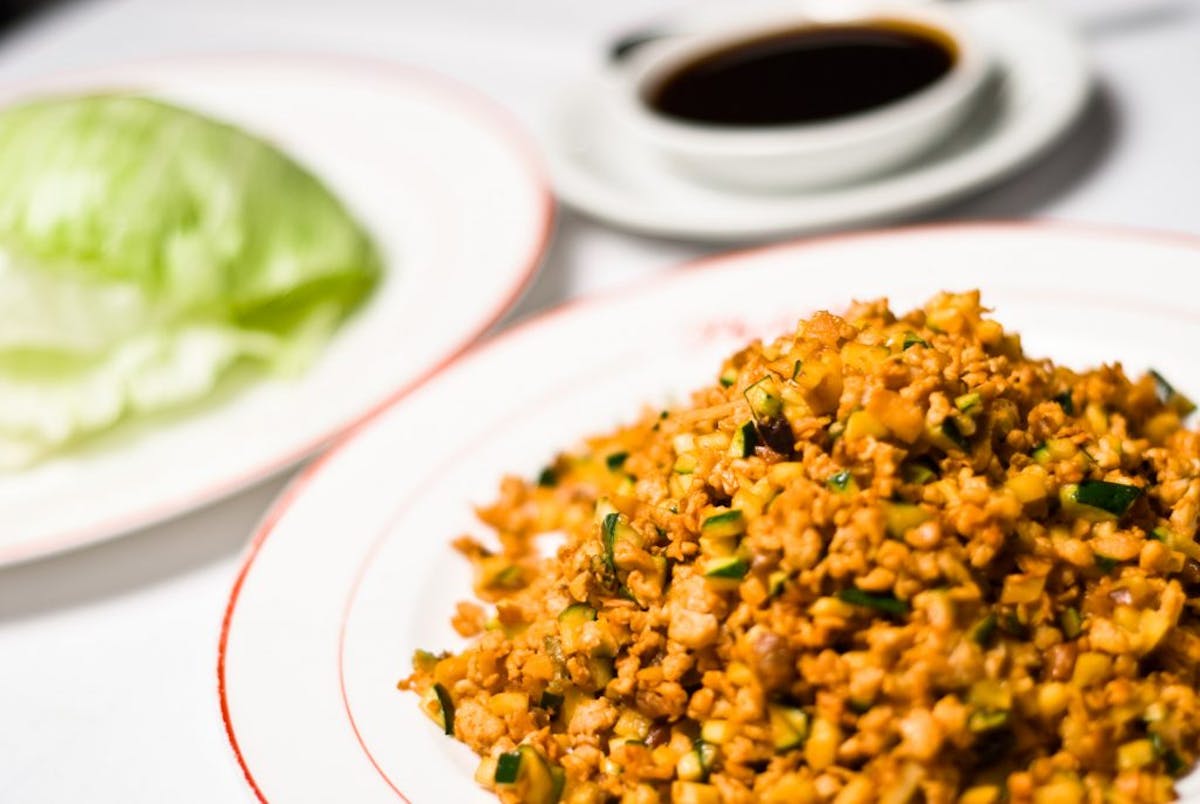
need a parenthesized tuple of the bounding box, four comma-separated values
(544, 0, 1092, 241)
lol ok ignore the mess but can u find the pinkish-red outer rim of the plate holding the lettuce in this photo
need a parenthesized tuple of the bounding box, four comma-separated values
(0, 49, 558, 568)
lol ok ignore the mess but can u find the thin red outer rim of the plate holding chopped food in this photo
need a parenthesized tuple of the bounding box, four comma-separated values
(215, 220, 1200, 804)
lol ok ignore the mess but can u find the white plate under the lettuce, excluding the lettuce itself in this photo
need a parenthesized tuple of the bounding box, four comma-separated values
(0, 55, 553, 565)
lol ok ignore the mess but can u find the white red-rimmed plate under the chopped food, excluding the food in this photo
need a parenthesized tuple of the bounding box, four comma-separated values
(217, 224, 1200, 804)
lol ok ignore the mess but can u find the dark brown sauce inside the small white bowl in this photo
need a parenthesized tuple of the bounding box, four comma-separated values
(647, 23, 954, 127)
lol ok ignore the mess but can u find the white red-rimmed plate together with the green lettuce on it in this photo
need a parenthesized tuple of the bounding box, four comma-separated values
(0, 56, 552, 564)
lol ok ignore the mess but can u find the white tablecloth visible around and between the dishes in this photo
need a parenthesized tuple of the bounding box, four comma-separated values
(0, 0, 1200, 803)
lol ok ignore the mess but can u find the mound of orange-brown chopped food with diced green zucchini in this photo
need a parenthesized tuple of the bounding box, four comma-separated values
(401, 293, 1200, 804)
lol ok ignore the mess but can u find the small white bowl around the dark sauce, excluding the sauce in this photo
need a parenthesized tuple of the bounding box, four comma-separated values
(614, 1, 989, 191)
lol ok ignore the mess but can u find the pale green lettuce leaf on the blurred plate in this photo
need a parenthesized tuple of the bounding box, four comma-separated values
(0, 95, 380, 468)
